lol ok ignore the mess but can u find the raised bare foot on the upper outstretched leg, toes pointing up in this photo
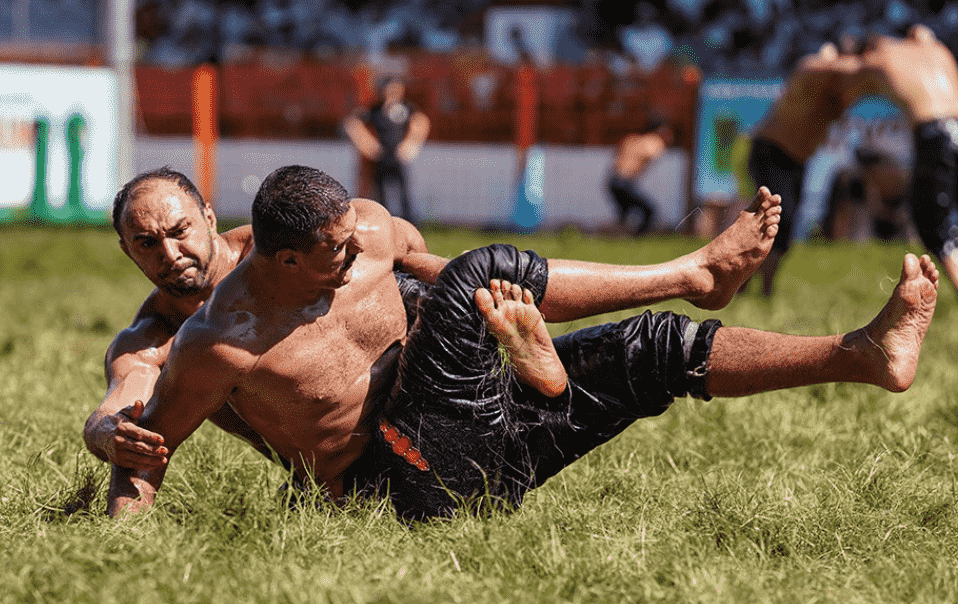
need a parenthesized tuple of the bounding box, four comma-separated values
(686, 187, 782, 310)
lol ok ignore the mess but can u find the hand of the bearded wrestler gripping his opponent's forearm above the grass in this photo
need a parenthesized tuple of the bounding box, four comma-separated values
(100, 401, 170, 470)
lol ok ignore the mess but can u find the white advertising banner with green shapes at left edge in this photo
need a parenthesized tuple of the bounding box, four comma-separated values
(0, 64, 119, 224)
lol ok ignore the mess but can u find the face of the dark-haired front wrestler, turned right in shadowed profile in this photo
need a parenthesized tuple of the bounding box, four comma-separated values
(301, 206, 363, 289)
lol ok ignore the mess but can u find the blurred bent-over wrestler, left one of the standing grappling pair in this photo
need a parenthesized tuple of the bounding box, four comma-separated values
(748, 43, 861, 296)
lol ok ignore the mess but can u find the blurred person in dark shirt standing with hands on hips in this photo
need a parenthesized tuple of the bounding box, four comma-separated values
(343, 76, 430, 222)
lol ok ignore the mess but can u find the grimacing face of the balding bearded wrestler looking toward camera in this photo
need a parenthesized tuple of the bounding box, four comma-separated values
(120, 180, 216, 298)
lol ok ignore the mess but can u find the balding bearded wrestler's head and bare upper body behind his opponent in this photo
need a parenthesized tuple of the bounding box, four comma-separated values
(83, 168, 427, 470)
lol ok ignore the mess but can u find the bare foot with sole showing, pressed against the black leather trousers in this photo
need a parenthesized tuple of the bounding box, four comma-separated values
(475, 279, 568, 397)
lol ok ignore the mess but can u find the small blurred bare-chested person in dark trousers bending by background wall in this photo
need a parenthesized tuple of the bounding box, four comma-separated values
(607, 124, 673, 235)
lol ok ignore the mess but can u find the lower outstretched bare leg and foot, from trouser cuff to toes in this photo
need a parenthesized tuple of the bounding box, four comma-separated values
(706, 254, 938, 396)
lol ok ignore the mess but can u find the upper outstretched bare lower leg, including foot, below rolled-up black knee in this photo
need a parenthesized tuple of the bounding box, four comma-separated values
(539, 187, 781, 323)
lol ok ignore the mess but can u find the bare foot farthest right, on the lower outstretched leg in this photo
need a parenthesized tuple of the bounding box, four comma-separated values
(842, 254, 938, 392)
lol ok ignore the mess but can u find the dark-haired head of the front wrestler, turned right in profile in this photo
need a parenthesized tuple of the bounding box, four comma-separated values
(252, 166, 362, 288)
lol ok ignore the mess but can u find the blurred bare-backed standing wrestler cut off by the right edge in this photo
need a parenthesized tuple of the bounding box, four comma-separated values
(862, 25, 958, 288)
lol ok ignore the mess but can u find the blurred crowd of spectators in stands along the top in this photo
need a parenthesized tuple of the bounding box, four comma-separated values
(0, 0, 958, 75)
